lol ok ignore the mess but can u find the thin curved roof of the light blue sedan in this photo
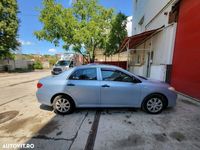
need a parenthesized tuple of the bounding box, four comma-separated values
(75, 63, 122, 69)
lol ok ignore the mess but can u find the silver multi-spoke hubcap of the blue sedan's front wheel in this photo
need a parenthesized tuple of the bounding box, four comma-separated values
(147, 98, 163, 112)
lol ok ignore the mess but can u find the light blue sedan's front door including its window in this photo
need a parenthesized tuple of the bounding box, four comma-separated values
(101, 68, 141, 107)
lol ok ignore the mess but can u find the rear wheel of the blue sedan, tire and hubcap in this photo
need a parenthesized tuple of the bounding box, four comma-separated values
(53, 95, 75, 115)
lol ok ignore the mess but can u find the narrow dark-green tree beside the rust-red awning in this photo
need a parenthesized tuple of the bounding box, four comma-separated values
(104, 12, 127, 56)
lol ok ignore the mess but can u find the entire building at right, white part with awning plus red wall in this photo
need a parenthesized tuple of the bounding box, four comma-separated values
(121, 0, 200, 99)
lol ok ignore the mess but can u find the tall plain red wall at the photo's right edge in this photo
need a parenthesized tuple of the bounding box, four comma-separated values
(171, 0, 200, 99)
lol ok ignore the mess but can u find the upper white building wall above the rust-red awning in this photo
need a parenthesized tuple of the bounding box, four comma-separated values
(132, 0, 177, 34)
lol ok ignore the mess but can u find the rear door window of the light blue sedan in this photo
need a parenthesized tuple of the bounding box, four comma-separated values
(69, 68, 97, 80)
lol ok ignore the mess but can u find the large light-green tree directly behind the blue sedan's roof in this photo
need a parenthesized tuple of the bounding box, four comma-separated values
(35, 0, 113, 62)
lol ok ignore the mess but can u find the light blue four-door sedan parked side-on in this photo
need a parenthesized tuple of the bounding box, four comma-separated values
(36, 64, 177, 114)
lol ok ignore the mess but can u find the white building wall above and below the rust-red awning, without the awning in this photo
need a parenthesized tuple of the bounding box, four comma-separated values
(131, 0, 177, 81)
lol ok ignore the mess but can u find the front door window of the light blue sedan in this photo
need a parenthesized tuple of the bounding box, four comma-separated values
(101, 69, 133, 82)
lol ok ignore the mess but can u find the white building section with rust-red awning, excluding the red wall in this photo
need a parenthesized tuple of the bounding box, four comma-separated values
(124, 0, 178, 81)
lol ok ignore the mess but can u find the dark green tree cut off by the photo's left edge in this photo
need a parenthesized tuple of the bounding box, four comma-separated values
(0, 0, 20, 58)
